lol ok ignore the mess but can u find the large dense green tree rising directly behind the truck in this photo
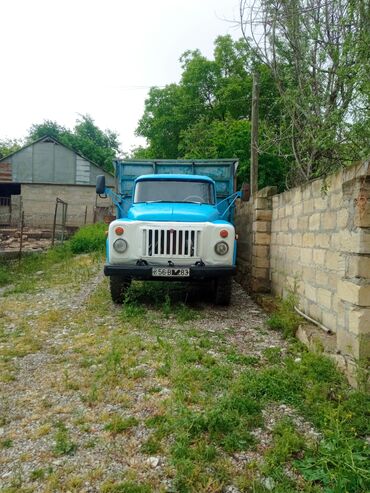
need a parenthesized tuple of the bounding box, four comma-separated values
(134, 36, 288, 189)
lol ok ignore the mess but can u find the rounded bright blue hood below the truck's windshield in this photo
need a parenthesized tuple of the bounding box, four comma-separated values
(127, 202, 220, 222)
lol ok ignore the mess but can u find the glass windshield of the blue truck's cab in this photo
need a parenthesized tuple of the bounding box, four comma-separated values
(134, 180, 214, 205)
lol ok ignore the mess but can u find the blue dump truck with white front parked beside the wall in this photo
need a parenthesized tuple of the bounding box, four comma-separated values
(96, 159, 239, 305)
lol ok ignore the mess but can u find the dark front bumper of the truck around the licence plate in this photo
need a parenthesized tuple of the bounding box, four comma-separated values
(104, 264, 236, 282)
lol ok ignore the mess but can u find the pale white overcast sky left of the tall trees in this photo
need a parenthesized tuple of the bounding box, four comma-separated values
(0, 0, 240, 151)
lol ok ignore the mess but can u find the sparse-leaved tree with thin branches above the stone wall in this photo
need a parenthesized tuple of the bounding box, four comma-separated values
(240, 0, 370, 184)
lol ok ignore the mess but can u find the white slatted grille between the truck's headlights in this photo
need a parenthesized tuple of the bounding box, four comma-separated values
(144, 228, 200, 258)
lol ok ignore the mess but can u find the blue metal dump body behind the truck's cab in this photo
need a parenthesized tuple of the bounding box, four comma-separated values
(115, 159, 238, 217)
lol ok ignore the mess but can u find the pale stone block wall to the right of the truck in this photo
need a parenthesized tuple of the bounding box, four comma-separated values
(236, 163, 370, 380)
